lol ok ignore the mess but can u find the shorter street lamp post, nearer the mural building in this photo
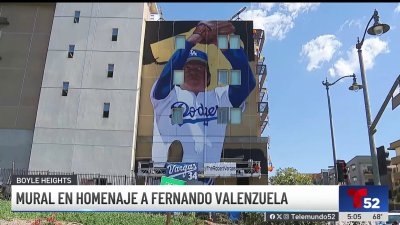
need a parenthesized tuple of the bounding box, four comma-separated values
(322, 73, 362, 185)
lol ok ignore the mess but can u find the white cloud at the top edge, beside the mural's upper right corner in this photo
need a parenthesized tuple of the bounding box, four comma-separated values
(240, 3, 319, 40)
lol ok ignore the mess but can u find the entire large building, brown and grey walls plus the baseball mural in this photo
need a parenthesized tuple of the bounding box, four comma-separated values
(0, 3, 269, 184)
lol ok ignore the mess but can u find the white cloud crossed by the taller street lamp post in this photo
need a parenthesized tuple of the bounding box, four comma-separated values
(328, 37, 390, 76)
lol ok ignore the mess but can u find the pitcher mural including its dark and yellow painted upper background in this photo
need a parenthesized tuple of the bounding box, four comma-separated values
(142, 21, 256, 170)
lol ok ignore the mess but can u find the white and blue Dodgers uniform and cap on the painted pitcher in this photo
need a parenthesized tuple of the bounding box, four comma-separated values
(150, 41, 255, 169)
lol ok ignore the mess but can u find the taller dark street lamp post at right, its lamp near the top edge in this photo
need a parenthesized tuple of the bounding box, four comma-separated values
(356, 9, 390, 185)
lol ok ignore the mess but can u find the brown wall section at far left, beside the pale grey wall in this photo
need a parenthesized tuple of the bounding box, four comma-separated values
(0, 2, 55, 168)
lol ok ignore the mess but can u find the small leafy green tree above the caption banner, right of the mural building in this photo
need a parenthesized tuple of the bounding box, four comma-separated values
(269, 167, 313, 185)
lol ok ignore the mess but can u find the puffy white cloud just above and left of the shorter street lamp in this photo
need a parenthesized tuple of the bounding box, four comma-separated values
(300, 34, 342, 71)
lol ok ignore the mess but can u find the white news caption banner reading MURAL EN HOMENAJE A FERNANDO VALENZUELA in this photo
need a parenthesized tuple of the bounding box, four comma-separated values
(11, 175, 388, 221)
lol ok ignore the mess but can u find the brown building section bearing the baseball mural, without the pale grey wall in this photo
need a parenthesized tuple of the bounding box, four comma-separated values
(135, 21, 268, 184)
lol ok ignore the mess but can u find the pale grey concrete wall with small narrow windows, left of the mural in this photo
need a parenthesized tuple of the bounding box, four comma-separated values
(29, 3, 146, 174)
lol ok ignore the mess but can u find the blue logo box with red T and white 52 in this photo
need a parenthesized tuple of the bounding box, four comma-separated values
(339, 186, 389, 212)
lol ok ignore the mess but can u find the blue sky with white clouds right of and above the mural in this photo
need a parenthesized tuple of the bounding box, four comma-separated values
(158, 3, 400, 173)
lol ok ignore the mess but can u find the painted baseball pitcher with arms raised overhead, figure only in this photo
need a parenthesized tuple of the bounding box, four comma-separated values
(150, 21, 256, 170)
